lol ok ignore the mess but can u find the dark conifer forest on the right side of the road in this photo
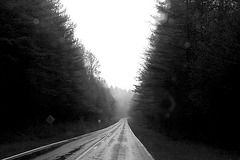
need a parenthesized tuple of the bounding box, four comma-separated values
(130, 0, 240, 150)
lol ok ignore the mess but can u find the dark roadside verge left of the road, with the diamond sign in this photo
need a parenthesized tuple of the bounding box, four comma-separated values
(0, 122, 114, 159)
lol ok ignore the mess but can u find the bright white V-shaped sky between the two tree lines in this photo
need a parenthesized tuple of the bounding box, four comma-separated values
(62, 0, 156, 89)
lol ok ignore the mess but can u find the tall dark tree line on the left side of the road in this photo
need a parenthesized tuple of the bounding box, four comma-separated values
(0, 0, 115, 131)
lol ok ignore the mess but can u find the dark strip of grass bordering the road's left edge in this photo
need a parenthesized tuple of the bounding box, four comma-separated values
(0, 121, 114, 159)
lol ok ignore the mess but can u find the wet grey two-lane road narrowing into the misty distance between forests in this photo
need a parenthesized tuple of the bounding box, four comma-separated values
(7, 119, 153, 160)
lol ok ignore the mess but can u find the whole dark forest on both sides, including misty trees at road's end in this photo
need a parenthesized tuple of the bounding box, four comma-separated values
(0, 0, 240, 153)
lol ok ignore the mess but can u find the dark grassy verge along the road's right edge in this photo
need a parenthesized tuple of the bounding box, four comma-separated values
(129, 122, 240, 160)
